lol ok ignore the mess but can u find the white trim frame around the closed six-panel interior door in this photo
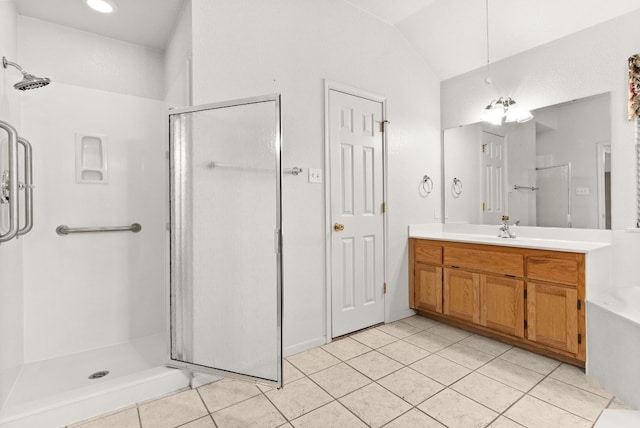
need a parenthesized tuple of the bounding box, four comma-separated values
(324, 79, 389, 343)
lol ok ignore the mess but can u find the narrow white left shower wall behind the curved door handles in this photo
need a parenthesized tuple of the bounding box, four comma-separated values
(0, 1, 24, 408)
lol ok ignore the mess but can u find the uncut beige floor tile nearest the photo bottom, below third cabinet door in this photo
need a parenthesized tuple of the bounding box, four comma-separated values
(451, 372, 523, 413)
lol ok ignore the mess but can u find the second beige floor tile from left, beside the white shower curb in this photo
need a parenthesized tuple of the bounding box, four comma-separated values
(138, 389, 208, 428)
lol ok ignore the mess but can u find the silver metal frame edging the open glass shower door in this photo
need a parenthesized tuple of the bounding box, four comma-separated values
(166, 94, 283, 388)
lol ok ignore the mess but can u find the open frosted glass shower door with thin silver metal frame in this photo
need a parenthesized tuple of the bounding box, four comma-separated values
(169, 95, 282, 386)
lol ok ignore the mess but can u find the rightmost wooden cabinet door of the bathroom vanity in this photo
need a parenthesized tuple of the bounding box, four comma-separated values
(527, 282, 578, 353)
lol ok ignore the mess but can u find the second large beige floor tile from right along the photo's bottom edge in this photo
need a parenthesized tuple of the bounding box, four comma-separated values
(418, 389, 498, 428)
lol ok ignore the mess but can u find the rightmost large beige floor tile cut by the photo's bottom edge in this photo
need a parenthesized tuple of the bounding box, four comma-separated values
(504, 395, 592, 428)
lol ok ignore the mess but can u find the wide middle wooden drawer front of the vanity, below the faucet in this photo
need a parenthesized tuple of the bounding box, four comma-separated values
(444, 247, 524, 277)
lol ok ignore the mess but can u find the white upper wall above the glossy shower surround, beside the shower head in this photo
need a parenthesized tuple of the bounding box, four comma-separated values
(18, 16, 164, 100)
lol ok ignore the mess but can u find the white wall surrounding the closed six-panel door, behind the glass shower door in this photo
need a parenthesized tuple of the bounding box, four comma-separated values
(192, 0, 440, 353)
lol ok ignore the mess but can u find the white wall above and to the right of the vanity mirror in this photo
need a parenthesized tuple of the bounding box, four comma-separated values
(441, 12, 640, 285)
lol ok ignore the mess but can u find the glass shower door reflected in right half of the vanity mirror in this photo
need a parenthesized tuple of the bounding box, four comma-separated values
(536, 164, 572, 227)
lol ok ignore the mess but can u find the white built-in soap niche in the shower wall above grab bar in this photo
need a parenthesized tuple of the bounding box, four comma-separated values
(76, 134, 109, 184)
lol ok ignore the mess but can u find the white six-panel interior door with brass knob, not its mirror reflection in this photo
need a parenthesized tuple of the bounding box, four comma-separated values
(328, 90, 385, 337)
